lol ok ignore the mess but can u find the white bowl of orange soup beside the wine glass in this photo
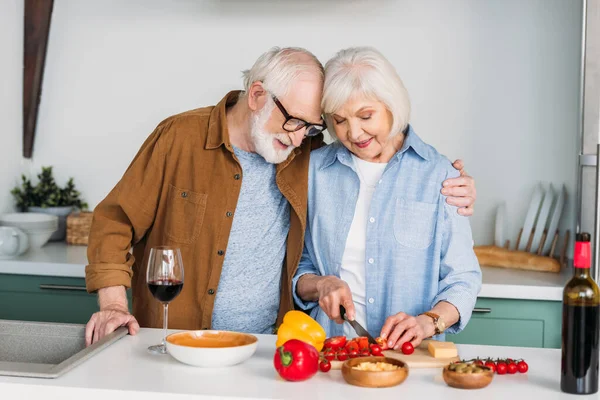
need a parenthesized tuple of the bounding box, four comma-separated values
(166, 330, 258, 367)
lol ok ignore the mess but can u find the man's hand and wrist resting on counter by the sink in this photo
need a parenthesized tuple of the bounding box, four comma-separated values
(85, 286, 140, 346)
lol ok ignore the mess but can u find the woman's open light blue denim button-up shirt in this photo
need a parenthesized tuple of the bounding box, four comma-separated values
(293, 127, 481, 340)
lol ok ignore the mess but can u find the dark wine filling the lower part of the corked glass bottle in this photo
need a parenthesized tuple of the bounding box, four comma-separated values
(561, 304, 600, 394)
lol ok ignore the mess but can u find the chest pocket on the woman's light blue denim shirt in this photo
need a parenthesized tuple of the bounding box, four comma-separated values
(394, 198, 438, 249)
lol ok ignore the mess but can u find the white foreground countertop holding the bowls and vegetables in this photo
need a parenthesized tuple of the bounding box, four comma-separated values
(0, 329, 600, 400)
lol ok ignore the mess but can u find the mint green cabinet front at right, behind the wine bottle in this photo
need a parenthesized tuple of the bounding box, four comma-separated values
(446, 298, 562, 348)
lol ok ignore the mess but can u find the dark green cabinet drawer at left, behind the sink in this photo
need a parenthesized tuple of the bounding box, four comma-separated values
(0, 274, 131, 324)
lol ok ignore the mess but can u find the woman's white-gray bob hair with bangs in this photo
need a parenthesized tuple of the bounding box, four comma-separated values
(321, 47, 410, 138)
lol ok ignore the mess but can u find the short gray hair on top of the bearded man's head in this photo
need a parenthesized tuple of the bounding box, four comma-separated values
(243, 47, 324, 97)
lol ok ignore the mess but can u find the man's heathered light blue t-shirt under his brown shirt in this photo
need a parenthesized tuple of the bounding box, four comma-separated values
(212, 147, 290, 334)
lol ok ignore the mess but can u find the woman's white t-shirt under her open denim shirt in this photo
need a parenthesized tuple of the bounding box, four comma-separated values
(340, 155, 387, 337)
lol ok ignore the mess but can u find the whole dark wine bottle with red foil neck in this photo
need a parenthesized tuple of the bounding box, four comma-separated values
(560, 233, 600, 394)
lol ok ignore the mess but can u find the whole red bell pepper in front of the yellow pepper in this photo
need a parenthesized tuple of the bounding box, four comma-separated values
(273, 339, 319, 382)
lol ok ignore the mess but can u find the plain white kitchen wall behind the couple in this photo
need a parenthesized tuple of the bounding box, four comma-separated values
(0, 0, 581, 248)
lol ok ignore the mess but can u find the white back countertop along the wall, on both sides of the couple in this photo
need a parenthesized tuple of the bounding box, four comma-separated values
(0, 242, 572, 301)
